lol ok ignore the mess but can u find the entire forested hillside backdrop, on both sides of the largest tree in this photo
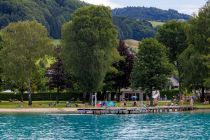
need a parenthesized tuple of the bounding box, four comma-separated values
(0, 0, 189, 40)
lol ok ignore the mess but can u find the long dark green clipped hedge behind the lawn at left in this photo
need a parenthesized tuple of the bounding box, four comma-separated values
(0, 92, 82, 101)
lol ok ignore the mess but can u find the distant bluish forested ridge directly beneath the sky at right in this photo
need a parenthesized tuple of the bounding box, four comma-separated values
(113, 7, 190, 21)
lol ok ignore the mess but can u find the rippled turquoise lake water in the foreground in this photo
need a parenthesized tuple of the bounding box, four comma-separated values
(0, 112, 210, 140)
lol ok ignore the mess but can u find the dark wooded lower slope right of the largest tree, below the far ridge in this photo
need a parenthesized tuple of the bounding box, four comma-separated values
(113, 16, 156, 40)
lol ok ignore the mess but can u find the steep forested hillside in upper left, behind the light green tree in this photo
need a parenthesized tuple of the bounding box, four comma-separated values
(0, 0, 85, 38)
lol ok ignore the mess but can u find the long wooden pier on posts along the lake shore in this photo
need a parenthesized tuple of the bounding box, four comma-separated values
(77, 106, 195, 114)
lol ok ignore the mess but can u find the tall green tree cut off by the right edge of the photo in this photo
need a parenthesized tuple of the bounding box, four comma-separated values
(179, 4, 210, 101)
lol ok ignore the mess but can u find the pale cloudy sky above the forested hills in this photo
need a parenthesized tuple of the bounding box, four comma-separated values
(81, 0, 207, 15)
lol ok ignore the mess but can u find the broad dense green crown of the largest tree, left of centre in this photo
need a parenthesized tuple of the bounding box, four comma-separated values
(62, 6, 117, 99)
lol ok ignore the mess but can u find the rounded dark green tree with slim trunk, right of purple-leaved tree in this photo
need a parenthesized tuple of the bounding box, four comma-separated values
(131, 39, 173, 105)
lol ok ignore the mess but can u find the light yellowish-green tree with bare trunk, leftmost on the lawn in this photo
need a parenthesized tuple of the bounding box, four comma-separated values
(0, 21, 51, 105)
